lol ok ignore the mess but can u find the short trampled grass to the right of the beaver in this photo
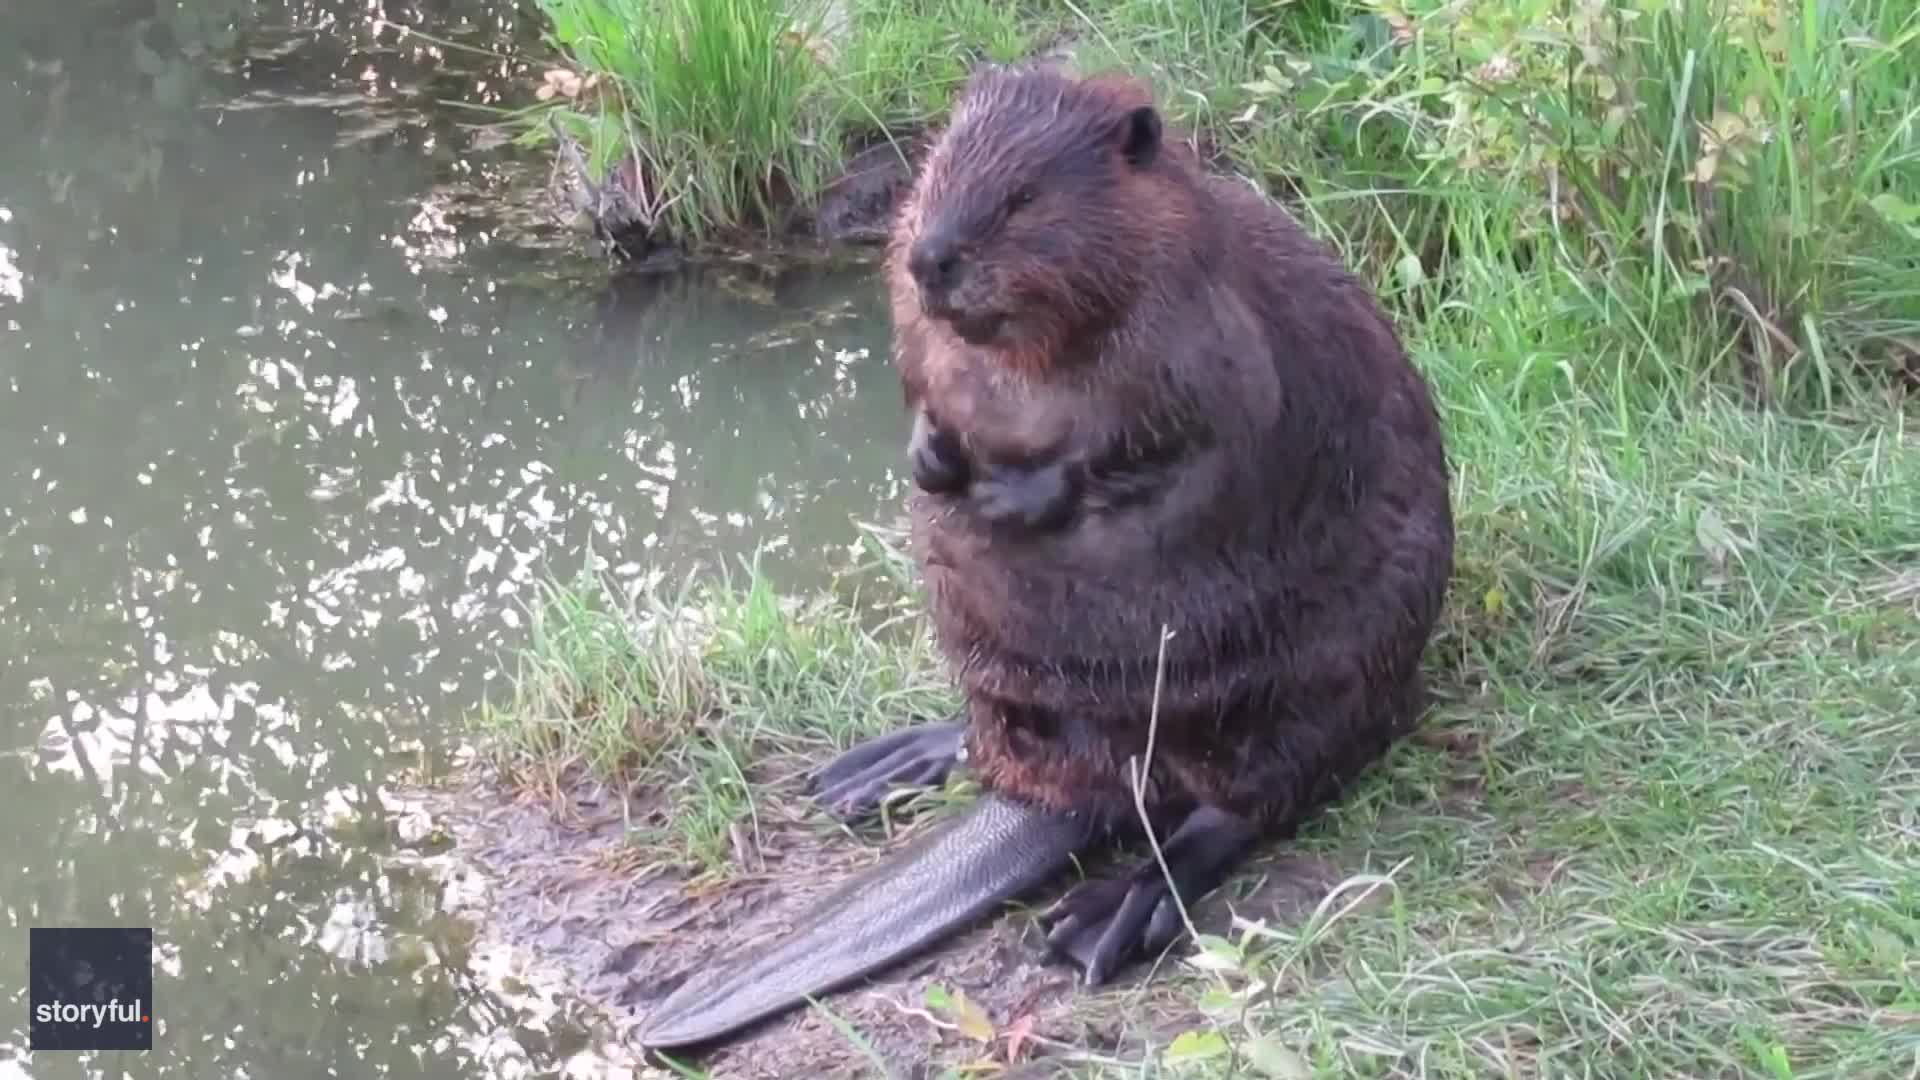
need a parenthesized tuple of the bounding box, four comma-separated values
(1152, 372, 1920, 1078)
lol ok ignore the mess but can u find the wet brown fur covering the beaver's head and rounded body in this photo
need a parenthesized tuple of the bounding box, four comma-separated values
(887, 69, 1453, 828)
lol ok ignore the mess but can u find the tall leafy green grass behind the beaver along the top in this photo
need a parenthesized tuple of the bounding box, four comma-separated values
(528, 0, 1920, 396)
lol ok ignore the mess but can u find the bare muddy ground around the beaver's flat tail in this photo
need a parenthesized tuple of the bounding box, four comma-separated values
(417, 760, 1340, 1080)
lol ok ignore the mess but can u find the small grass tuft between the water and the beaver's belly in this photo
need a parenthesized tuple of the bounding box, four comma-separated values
(472, 549, 958, 874)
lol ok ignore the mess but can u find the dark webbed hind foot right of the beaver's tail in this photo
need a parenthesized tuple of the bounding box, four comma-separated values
(1041, 805, 1260, 986)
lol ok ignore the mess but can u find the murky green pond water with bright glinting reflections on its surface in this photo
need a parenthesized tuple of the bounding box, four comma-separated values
(0, 0, 904, 1080)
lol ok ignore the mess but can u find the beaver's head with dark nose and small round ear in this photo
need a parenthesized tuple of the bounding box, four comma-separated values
(889, 67, 1192, 354)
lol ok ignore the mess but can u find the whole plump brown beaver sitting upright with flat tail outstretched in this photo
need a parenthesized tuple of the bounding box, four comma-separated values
(639, 67, 1453, 1047)
